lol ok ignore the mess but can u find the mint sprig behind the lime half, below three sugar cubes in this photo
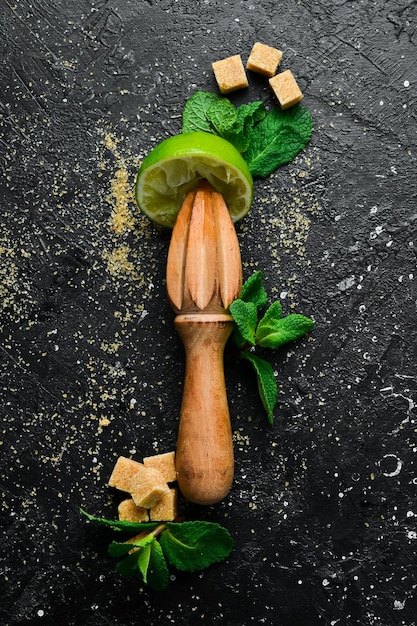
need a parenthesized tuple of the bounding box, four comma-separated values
(182, 91, 313, 178)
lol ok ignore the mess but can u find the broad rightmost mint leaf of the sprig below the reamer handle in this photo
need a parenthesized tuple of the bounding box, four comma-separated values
(160, 521, 233, 572)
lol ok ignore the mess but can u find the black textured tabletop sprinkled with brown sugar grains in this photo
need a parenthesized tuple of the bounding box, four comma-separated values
(0, 0, 417, 626)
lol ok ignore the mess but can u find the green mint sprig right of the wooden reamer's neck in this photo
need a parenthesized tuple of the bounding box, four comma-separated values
(229, 271, 314, 425)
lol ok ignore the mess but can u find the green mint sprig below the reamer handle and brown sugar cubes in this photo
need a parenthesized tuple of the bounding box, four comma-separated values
(81, 509, 234, 591)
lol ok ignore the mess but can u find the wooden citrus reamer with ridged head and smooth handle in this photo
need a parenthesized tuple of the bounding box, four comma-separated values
(167, 181, 242, 504)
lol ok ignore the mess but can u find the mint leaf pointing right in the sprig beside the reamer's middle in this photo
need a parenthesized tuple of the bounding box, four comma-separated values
(256, 312, 314, 348)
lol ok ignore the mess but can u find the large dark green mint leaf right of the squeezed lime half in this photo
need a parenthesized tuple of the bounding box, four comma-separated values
(243, 104, 313, 178)
